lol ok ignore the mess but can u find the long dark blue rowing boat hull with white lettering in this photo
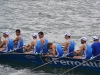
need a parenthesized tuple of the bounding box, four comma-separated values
(0, 53, 100, 71)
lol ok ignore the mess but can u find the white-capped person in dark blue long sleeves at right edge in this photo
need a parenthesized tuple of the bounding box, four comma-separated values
(91, 36, 100, 60)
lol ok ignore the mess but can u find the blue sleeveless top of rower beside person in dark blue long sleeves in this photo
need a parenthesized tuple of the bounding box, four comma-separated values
(82, 44, 92, 59)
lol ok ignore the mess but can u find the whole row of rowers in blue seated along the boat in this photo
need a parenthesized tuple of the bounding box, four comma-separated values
(0, 29, 100, 60)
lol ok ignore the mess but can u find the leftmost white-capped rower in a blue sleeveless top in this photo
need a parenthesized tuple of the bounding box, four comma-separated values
(0, 31, 13, 52)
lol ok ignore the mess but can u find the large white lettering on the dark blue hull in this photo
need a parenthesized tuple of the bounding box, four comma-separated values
(52, 58, 100, 68)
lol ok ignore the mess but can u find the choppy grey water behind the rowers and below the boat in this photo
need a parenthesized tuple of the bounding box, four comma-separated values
(0, 0, 100, 75)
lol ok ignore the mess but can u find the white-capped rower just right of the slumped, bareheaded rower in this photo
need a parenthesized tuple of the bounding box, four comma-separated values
(63, 33, 75, 57)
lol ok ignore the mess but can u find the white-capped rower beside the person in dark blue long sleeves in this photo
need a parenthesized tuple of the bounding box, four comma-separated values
(73, 37, 92, 59)
